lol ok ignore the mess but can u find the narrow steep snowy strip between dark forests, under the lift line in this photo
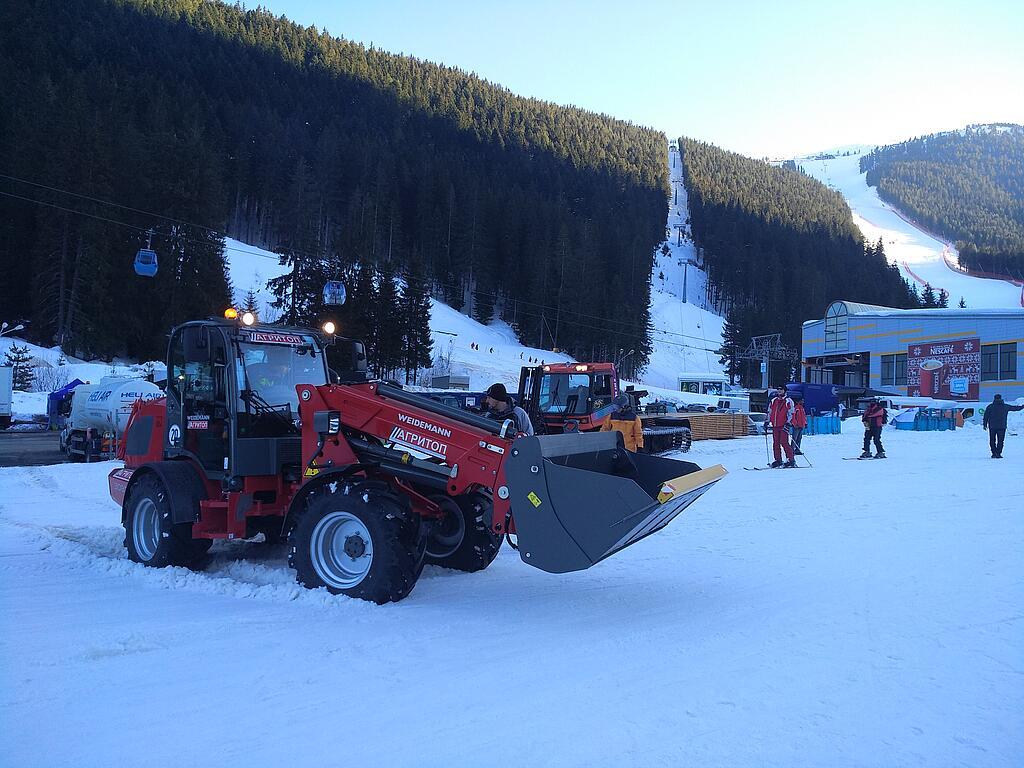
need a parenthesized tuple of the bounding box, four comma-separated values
(643, 145, 725, 392)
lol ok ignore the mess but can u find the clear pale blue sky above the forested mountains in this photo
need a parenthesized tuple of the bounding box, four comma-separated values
(262, 0, 1024, 157)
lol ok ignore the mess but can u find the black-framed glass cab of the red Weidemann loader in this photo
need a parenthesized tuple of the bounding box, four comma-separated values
(164, 321, 328, 478)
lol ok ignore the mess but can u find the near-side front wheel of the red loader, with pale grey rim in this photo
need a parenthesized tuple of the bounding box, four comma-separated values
(288, 483, 423, 605)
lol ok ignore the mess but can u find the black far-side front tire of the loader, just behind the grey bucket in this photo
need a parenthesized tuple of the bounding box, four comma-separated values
(425, 493, 505, 572)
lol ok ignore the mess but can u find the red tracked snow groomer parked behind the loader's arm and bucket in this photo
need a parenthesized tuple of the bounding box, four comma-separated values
(518, 362, 692, 454)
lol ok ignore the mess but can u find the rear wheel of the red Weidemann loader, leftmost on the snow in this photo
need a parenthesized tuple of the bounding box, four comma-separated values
(124, 474, 204, 568)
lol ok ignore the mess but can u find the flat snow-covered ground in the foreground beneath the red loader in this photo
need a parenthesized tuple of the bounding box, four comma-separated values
(0, 430, 1024, 768)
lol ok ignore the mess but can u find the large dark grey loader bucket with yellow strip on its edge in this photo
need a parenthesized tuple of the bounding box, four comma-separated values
(505, 432, 726, 573)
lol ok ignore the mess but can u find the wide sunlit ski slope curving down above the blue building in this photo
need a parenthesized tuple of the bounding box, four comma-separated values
(796, 155, 1024, 309)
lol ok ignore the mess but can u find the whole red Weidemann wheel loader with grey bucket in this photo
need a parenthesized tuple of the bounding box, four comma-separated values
(109, 319, 725, 603)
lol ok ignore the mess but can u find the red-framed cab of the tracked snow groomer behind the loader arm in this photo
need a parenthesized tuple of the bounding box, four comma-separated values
(519, 362, 618, 434)
